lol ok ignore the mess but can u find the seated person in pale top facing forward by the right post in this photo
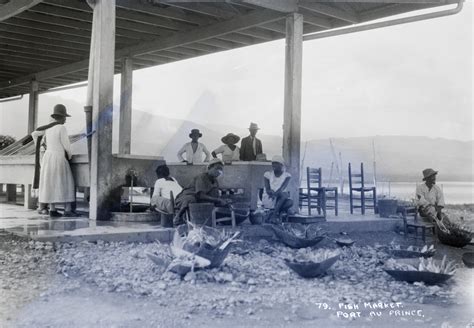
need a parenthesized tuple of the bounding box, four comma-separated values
(262, 155, 293, 219)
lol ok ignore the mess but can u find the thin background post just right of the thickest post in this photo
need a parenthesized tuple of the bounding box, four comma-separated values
(119, 57, 133, 154)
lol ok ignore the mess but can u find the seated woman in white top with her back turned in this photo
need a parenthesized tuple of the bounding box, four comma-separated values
(151, 164, 183, 214)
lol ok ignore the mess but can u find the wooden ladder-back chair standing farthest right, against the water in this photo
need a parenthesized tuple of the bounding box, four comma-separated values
(349, 163, 377, 214)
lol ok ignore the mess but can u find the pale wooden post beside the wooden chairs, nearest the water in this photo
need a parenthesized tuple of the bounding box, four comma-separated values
(283, 13, 303, 210)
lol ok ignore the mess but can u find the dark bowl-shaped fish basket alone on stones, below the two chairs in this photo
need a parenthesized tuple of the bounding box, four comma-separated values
(285, 249, 339, 278)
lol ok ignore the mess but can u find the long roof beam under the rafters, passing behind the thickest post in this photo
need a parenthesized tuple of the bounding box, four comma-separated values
(0, 10, 283, 90)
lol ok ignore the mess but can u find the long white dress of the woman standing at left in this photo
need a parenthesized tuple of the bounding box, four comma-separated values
(31, 124, 75, 203)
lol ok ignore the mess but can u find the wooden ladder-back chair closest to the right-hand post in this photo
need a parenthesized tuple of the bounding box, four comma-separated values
(306, 167, 338, 217)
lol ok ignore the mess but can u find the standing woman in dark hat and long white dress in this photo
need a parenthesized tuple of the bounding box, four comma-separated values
(31, 104, 75, 217)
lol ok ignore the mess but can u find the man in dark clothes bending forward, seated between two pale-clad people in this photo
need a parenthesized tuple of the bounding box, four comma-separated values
(173, 158, 231, 226)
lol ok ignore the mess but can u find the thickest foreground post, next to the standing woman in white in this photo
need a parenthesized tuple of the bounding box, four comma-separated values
(89, 0, 115, 220)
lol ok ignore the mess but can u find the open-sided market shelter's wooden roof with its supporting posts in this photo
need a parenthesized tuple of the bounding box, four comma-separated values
(0, 0, 462, 219)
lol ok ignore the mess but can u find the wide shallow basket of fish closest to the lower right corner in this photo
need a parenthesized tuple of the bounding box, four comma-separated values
(384, 256, 456, 285)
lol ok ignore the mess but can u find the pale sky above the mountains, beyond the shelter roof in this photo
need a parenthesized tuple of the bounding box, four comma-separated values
(0, 0, 473, 141)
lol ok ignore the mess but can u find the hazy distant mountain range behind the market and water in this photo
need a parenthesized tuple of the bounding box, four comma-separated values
(1, 95, 474, 181)
